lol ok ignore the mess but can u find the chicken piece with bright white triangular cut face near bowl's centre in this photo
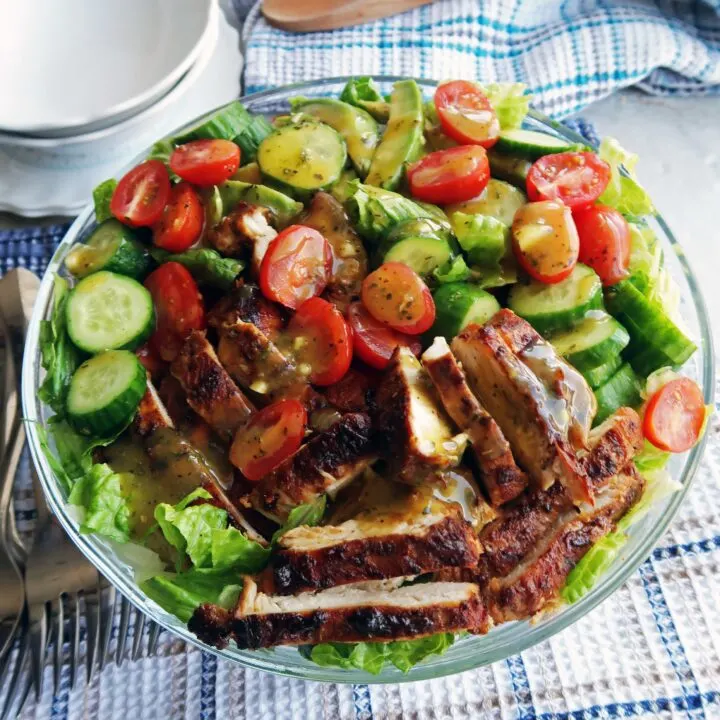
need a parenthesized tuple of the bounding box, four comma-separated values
(375, 347, 467, 484)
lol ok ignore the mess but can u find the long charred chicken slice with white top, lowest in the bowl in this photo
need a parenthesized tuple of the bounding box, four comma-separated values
(188, 578, 489, 649)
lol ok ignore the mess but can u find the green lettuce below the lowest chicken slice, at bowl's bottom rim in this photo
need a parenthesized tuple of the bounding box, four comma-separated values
(309, 633, 455, 675)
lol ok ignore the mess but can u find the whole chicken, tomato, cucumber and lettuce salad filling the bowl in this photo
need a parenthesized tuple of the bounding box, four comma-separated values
(40, 78, 708, 673)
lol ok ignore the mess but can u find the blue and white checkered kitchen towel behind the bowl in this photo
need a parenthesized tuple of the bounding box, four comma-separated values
(234, 0, 720, 117)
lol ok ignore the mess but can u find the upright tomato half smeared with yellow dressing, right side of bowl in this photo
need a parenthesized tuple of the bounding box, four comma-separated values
(512, 200, 580, 285)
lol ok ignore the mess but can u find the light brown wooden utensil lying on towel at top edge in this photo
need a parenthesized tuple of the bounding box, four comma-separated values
(263, 0, 431, 32)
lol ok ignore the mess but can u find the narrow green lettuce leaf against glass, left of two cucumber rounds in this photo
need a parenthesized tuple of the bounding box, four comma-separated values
(38, 275, 82, 416)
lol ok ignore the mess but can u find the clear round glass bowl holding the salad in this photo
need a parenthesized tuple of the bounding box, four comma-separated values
(22, 77, 714, 683)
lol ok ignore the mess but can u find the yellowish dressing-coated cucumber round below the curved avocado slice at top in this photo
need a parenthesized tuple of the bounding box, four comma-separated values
(257, 123, 347, 198)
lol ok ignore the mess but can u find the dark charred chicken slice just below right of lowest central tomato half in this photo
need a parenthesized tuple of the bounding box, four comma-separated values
(249, 413, 377, 522)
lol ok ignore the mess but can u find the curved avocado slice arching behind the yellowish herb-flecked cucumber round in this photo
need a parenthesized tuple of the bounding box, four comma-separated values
(292, 98, 380, 178)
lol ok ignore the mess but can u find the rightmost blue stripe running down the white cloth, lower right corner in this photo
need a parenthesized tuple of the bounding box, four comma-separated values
(639, 559, 705, 717)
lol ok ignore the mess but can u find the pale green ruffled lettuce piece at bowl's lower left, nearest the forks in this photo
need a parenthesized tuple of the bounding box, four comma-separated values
(68, 464, 130, 542)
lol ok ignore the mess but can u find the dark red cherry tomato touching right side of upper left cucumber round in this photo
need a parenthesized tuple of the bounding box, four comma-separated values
(145, 262, 205, 362)
